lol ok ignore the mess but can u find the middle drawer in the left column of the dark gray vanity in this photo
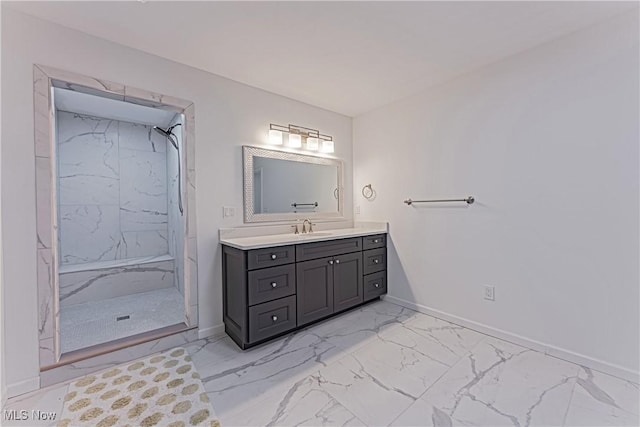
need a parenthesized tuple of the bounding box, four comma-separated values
(248, 264, 296, 305)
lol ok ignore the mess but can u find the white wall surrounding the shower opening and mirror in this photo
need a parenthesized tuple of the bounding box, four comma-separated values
(1, 5, 352, 393)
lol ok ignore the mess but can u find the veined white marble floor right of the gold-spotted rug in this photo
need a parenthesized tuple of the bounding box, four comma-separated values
(182, 301, 639, 427)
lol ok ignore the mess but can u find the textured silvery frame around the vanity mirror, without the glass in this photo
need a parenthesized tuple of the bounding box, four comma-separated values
(242, 145, 344, 222)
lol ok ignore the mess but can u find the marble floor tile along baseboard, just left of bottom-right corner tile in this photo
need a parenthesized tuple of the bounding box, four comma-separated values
(412, 337, 578, 426)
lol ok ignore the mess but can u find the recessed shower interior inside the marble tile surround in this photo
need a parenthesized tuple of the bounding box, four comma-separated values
(41, 74, 193, 364)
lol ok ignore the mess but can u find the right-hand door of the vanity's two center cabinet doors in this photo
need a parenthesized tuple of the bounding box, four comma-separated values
(333, 252, 363, 312)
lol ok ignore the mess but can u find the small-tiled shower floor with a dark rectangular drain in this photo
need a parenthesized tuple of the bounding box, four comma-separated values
(60, 288, 185, 353)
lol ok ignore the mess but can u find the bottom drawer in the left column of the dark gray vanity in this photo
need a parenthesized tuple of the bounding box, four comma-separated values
(249, 295, 296, 342)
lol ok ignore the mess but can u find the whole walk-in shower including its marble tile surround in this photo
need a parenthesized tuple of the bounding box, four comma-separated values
(34, 65, 197, 370)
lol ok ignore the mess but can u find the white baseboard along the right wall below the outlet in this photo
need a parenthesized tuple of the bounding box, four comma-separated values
(384, 295, 640, 384)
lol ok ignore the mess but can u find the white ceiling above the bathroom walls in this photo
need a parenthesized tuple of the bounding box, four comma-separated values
(2, 1, 638, 116)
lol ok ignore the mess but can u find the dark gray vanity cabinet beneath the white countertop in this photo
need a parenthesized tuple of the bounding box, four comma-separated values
(222, 234, 387, 349)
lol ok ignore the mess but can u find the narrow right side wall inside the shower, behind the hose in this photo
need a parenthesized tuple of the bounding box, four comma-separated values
(166, 114, 186, 295)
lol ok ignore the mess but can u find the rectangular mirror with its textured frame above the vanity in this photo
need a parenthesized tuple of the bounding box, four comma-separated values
(242, 146, 344, 222)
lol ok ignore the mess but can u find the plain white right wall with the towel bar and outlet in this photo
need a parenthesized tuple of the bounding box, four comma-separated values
(354, 11, 639, 378)
